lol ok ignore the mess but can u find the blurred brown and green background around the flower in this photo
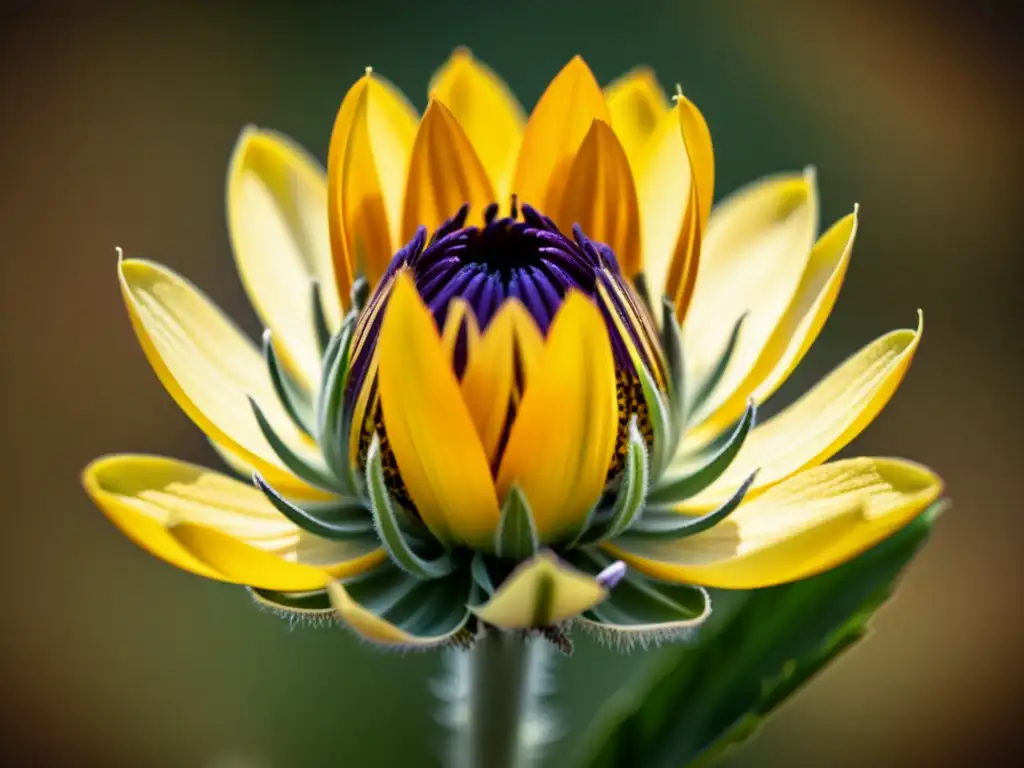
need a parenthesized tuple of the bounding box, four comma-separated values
(0, 0, 1024, 768)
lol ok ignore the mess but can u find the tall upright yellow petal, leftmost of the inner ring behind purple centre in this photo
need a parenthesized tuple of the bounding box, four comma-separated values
(328, 72, 418, 294)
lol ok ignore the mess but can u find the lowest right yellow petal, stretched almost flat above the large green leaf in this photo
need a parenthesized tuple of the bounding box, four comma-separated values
(609, 459, 942, 589)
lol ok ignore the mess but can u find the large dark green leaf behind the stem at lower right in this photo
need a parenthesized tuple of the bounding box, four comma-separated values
(580, 502, 943, 768)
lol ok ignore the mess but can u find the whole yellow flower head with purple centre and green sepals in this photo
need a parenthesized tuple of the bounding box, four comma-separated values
(84, 49, 941, 645)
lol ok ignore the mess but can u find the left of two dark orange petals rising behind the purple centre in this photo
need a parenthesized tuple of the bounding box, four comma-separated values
(401, 100, 496, 243)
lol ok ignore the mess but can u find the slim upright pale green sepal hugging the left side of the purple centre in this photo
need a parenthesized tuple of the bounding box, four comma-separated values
(316, 312, 359, 496)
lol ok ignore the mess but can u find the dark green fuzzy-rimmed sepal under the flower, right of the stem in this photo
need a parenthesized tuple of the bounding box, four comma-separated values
(569, 549, 711, 649)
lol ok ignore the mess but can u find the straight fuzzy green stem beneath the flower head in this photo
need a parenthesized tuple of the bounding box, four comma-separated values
(467, 630, 532, 768)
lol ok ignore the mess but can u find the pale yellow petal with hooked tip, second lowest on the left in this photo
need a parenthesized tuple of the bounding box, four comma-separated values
(118, 259, 325, 499)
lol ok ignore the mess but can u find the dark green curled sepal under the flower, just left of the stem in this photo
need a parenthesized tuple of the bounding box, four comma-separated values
(342, 560, 476, 647)
